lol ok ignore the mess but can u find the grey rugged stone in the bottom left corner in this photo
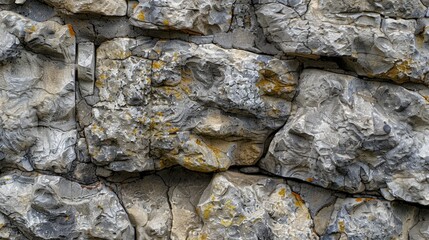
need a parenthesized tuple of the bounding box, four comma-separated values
(0, 172, 134, 239)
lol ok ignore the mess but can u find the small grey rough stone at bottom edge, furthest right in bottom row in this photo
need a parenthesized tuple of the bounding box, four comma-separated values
(321, 198, 418, 239)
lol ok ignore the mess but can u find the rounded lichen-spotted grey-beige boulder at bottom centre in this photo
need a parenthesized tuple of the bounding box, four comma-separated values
(189, 172, 317, 239)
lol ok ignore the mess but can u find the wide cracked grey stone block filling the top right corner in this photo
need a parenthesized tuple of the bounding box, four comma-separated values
(256, 0, 429, 84)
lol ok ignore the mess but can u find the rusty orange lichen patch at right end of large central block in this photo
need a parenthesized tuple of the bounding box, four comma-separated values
(256, 69, 295, 98)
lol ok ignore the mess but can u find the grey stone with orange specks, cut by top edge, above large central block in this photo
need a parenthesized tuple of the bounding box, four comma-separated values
(129, 0, 235, 35)
